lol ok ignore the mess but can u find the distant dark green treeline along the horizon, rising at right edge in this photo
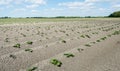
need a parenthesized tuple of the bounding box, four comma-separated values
(0, 11, 120, 19)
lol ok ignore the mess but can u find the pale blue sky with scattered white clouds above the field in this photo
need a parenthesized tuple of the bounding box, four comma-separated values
(0, 0, 120, 17)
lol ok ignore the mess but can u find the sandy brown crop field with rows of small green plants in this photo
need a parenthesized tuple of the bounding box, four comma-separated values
(0, 18, 120, 71)
